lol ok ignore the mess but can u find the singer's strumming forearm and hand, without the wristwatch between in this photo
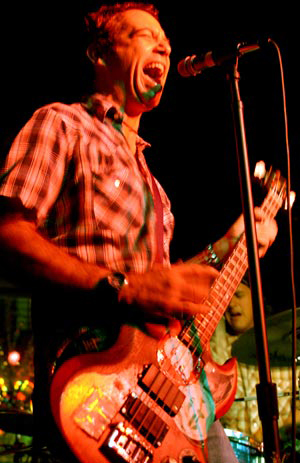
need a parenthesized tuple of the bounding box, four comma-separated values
(0, 220, 217, 334)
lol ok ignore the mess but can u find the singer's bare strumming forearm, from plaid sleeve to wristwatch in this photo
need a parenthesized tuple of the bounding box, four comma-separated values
(0, 219, 109, 289)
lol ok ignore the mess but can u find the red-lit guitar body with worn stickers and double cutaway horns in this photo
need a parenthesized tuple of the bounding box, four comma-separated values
(51, 325, 237, 463)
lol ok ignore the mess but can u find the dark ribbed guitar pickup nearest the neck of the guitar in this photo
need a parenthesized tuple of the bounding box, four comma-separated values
(138, 365, 185, 417)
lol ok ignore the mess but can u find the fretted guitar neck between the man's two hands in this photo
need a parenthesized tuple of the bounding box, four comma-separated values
(181, 185, 283, 351)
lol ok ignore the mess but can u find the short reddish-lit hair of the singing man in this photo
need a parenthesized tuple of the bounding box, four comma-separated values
(85, 2, 159, 58)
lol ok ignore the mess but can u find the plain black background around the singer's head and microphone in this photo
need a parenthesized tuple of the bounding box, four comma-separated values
(0, 0, 300, 312)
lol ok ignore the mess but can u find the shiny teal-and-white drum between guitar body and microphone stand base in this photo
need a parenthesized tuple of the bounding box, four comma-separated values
(225, 429, 265, 463)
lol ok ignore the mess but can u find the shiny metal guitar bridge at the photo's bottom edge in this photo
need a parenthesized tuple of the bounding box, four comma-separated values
(99, 422, 153, 463)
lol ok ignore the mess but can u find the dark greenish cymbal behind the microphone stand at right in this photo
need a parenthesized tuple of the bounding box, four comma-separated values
(231, 307, 300, 367)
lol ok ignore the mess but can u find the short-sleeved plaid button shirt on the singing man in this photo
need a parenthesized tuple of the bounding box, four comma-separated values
(0, 95, 174, 272)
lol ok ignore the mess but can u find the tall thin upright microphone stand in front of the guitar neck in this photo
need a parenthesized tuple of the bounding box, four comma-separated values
(228, 57, 281, 463)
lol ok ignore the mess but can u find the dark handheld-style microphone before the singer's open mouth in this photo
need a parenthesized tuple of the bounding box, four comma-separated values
(177, 43, 260, 77)
